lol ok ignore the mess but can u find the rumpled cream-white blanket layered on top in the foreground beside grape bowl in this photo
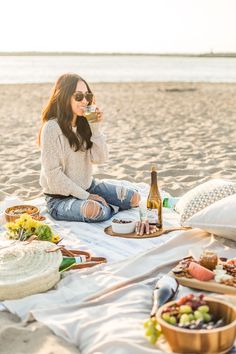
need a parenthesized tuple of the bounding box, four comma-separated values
(4, 230, 235, 354)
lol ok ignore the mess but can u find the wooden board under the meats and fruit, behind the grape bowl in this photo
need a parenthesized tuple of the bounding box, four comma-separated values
(170, 272, 236, 295)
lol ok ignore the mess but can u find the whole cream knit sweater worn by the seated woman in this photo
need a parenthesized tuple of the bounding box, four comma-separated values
(40, 119, 108, 199)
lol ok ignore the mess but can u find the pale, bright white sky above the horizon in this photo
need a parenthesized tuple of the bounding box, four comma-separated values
(0, 0, 236, 54)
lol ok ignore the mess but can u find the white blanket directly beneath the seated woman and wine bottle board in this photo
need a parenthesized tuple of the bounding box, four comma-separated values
(0, 180, 179, 262)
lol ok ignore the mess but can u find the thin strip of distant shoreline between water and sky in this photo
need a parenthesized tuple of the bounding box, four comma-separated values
(0, 51, 236, 58)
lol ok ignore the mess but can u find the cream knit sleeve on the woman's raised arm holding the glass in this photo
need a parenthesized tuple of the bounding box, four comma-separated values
(90, 123, 108, 164)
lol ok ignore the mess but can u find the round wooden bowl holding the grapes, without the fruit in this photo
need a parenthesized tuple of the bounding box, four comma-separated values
(156, 297, 236, 354)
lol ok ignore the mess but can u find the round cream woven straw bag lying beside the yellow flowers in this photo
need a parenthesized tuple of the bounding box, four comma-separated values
(0, 241, 62, 300)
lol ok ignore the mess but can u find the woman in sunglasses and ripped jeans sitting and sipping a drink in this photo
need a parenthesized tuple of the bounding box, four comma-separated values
(39, 74, 140, 222)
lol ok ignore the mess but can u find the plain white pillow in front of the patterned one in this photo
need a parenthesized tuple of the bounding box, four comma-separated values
(184, 194, 236, 241)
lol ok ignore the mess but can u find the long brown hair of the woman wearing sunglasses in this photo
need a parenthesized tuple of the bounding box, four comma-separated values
(38, 73, 93, 151)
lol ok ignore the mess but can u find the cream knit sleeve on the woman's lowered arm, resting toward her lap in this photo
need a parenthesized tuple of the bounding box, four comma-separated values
(41, 122, 89, 199)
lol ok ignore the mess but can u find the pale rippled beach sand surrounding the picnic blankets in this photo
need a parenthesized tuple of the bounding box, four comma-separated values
(0, 83, 236, 354)
